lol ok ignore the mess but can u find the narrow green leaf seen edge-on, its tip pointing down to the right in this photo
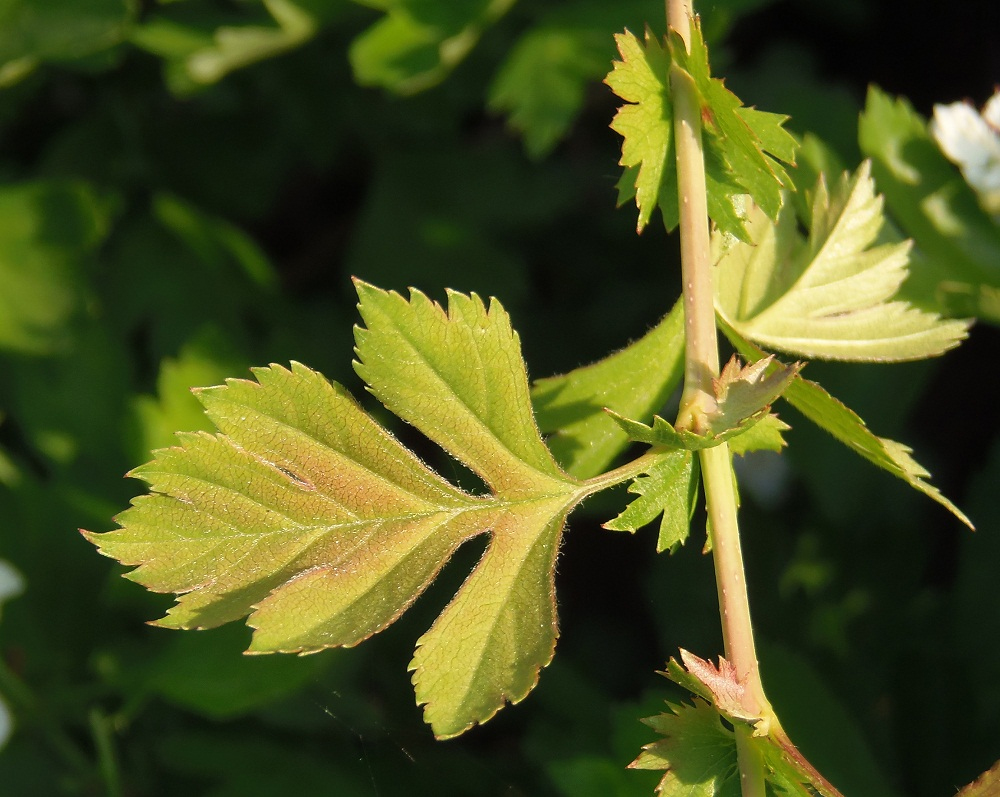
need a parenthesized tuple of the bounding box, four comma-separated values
(721, 322, 973, 529)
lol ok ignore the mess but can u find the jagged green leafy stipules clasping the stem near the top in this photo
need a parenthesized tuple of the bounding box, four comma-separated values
(605, 18, 797, 240)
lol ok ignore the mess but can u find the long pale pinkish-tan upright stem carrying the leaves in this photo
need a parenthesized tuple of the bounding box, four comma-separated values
(667, 0, 771, 797)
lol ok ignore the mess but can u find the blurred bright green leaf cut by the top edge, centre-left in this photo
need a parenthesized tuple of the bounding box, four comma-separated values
(350, 0, 515, 94)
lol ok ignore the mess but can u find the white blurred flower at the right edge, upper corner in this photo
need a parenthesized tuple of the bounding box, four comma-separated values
(931, 89, 1000, 219)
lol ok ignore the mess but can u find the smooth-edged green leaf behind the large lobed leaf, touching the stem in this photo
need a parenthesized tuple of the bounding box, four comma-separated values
(531, 302, 684, 472)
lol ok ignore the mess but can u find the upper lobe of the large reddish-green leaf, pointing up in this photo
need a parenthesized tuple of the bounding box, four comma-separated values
(355, 281, 568, 496)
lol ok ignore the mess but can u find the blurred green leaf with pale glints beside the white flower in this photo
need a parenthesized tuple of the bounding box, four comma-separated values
(858, 87, 1000, 322)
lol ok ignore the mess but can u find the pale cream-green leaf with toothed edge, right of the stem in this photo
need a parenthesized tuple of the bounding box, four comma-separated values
(714, 162, 968, 362)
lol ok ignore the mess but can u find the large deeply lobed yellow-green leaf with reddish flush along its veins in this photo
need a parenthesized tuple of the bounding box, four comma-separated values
(87, 283, 592, 737)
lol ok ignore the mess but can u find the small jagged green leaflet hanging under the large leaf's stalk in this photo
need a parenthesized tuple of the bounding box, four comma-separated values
(604, 450, 698, 553)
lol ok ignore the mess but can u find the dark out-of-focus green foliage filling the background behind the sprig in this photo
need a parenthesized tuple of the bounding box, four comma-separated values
(0, 0, 1000, 797)
